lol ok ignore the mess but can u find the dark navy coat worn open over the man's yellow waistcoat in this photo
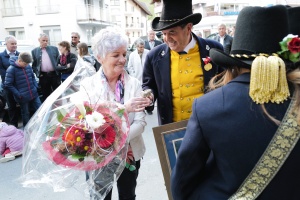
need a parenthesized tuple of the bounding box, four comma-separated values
(143, 35, 223, 124)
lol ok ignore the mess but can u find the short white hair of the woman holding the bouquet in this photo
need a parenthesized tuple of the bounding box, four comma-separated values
(92, 27, 128, 58)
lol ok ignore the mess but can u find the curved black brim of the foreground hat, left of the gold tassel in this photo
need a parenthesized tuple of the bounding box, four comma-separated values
(209, 48, 253, 69)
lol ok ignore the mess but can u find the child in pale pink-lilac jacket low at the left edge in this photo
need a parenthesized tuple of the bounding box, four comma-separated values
(0, 122, 24, 163)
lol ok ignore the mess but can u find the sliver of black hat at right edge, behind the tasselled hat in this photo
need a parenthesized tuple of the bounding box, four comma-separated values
(288, 7, 300, 36)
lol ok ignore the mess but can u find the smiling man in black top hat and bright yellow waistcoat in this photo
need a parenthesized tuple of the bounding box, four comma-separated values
(143, 0, 223, 125)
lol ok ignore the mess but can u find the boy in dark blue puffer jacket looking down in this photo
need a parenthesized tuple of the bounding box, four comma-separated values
(4, 52, 41, 127)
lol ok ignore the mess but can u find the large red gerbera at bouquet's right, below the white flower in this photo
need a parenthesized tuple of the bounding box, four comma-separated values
(95, 125, 116, 149)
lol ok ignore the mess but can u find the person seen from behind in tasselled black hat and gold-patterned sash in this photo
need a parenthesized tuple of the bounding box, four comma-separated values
(171, 5, 300, 200)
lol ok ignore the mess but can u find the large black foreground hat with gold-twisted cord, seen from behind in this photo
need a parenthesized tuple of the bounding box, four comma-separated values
(210, 5, 289, 69)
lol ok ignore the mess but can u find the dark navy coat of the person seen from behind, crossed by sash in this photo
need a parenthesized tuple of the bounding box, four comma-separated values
(171, 73, 300, 200)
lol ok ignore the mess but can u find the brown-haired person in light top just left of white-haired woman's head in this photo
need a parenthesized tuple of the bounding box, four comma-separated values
(74, 42, 96, 75)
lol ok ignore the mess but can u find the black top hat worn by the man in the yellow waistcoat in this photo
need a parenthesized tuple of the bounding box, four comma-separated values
(152, 0, 202, 31)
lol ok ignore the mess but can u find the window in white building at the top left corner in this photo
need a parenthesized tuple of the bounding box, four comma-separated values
(2, 0, 23, 17)
